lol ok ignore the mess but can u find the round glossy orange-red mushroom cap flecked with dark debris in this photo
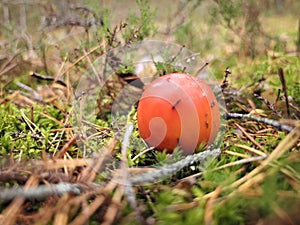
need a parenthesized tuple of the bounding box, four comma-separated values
(137, 73, 220, 154)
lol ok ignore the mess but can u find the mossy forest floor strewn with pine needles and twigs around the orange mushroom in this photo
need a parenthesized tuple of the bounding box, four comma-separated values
(0, 1, 300, 225)
